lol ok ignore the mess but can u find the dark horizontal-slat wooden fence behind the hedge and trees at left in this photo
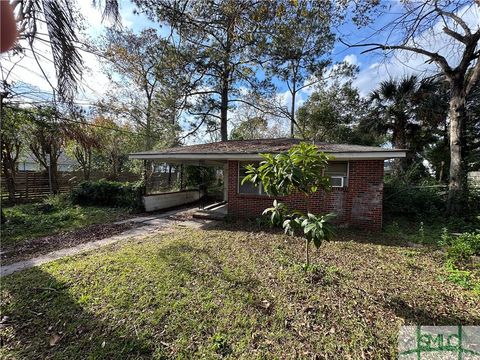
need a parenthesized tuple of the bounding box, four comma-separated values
(0, 171, 140, 201)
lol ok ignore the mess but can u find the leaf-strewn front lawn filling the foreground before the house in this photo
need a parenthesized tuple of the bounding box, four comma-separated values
(0, 225, 480, 359)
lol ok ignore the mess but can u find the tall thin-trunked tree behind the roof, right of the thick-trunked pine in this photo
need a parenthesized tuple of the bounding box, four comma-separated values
(261, 0, 337, 137)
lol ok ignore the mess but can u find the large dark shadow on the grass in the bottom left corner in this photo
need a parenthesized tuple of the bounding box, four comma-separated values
(0, 268, 153, 359)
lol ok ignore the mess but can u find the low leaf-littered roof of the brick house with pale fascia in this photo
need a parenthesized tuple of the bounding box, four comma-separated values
(130, 138, 405, 160)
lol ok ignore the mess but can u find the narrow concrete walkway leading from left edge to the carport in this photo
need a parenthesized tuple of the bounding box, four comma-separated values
(0, 209, 212, 277)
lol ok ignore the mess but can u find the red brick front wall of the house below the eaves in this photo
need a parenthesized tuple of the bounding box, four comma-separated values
(228, 160, 383, 230)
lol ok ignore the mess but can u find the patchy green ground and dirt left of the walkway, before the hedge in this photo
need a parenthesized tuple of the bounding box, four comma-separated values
(1, 195, 129, 264)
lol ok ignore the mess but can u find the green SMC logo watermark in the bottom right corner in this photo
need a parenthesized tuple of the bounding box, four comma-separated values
(398, 325, 480, 360)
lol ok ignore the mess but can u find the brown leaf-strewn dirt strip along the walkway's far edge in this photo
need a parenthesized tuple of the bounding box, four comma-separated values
(1, 222, 143, 265)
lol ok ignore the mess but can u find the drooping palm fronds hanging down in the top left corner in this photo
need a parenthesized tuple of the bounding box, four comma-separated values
(11, 0, 120, 100)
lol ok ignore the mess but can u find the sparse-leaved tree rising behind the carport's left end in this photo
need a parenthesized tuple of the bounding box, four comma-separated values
(104, 29, 180, 150)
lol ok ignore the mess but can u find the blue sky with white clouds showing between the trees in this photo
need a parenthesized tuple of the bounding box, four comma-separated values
(0, 0, 480, 142)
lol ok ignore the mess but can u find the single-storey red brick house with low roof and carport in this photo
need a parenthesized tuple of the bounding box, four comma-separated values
(130, 139, 406, 230)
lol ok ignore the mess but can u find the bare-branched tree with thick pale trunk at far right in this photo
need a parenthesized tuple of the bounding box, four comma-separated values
(344, 0, 480, 214)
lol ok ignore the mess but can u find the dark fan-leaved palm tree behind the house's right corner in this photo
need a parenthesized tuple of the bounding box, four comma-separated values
(364, 75, 446, 175)
